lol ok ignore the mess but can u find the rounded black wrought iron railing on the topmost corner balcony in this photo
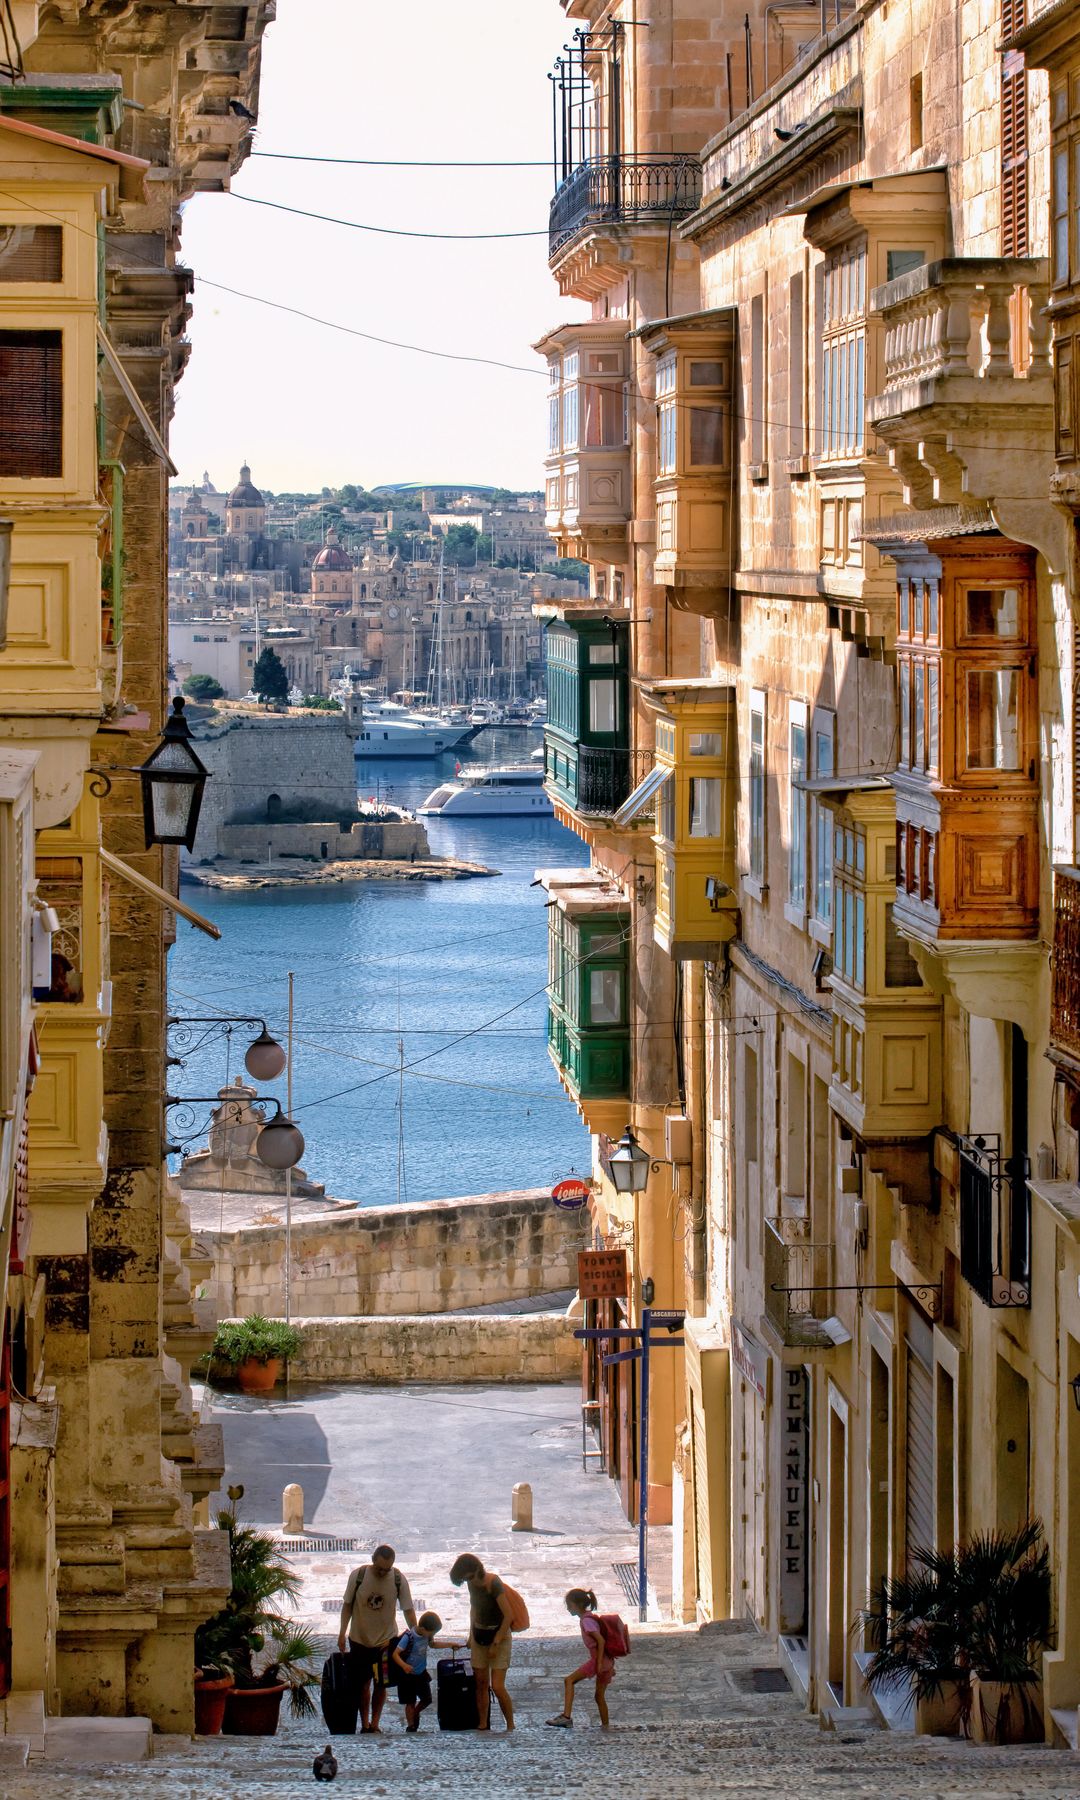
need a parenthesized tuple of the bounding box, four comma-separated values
(547, 155, 702, 257)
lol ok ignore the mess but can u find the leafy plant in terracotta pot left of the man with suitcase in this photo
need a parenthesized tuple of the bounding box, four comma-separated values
(194, 1505, 319, 1737)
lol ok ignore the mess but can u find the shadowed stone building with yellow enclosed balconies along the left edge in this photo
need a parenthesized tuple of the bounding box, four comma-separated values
(0, 0, 274, 1732)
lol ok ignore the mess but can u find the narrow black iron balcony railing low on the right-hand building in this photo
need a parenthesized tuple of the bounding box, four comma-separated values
(959, 1132, 1031, 1307)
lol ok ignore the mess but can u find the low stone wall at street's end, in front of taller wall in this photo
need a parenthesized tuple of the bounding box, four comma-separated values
(288, 1312, 581, 1384)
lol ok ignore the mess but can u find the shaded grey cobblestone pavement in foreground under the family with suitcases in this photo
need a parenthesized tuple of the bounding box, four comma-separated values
(0, 1622, 1080, 1800)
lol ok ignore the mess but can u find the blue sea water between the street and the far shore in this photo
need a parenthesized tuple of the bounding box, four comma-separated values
(169, 731, 589, 1206)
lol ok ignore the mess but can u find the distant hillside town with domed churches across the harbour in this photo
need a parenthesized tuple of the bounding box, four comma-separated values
(169, 464, 587, 702)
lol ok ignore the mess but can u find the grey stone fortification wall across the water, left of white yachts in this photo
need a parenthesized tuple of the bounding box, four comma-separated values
(193, 711, 356, 862)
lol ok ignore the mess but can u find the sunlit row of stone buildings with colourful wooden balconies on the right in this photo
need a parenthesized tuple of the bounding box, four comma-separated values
(540, 0, 1080, 1742)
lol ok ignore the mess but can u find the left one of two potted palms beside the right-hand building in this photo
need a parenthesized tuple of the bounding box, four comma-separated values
(860, 1550, 972, 1737)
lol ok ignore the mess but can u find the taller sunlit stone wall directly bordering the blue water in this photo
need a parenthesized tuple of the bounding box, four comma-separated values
(200, 1188, 589, 1318)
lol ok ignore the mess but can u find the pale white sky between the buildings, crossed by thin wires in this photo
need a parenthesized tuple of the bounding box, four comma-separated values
(171, 0, 583, 491)
